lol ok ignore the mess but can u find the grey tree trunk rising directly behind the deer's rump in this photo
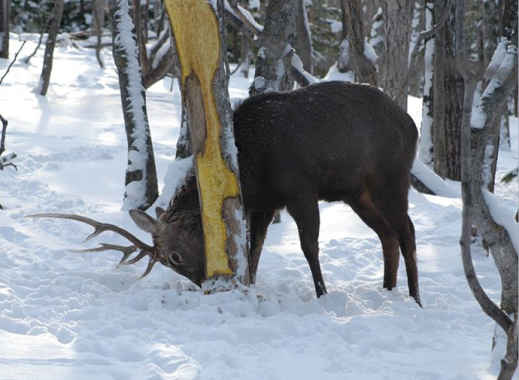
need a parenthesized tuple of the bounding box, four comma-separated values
(378, 0, 414, 110)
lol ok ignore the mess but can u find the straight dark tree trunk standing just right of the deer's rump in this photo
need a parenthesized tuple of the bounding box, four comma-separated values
(432, 0, 464, 181)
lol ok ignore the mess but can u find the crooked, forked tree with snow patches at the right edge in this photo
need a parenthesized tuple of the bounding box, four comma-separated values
(462, 0, 519, 380)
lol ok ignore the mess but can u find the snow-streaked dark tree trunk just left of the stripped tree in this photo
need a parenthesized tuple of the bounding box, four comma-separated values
(111, 0, 158, 210)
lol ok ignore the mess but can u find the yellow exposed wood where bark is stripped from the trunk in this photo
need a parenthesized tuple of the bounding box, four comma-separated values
(164, 0, 239, 278)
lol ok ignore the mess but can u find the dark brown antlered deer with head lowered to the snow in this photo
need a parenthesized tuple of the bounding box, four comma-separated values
(30, 81, 422, 306)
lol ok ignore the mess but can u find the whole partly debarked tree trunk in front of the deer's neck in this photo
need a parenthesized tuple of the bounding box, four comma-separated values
(165, 0, 249, 291)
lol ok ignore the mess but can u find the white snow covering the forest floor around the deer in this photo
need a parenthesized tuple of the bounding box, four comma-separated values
(0, 35, 518, 380)
